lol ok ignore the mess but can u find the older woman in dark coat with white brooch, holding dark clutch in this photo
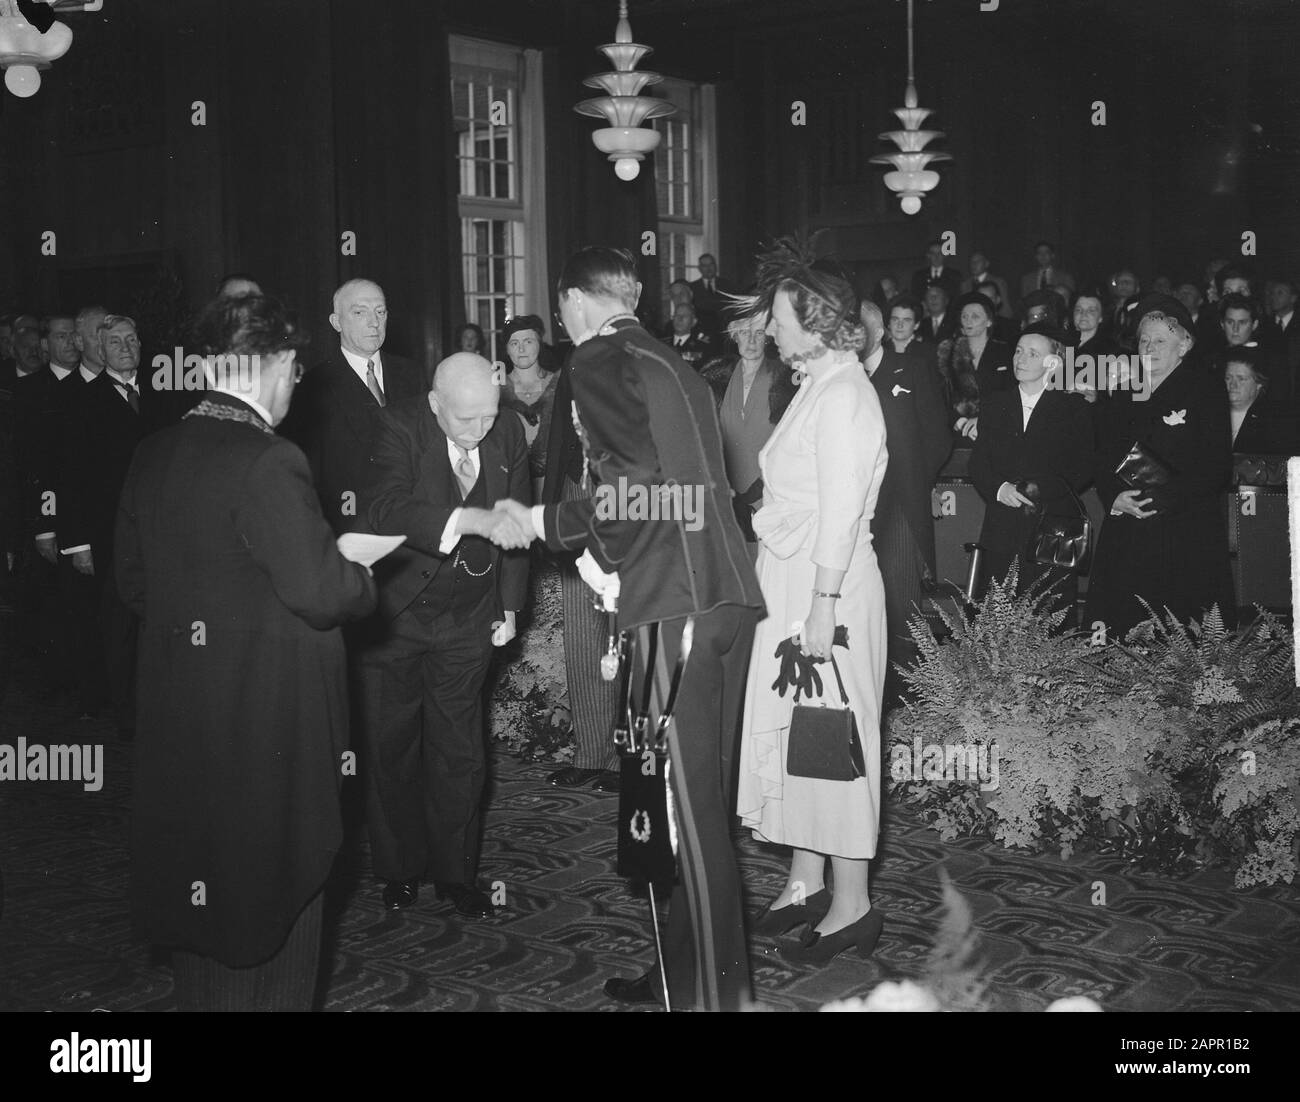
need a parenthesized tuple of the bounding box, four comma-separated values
(1086, 295, 1236, 638)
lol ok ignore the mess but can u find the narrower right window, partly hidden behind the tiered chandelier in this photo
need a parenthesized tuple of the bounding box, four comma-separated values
(654, 79, 718, 318)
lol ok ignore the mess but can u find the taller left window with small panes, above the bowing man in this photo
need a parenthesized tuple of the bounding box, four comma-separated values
(451, 36, 550, 360)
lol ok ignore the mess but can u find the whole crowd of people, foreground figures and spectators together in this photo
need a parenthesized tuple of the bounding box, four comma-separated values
(0, 240, 1300, 1010)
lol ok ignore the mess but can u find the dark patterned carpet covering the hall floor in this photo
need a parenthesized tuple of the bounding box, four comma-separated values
(0, 616, 1300, 1011)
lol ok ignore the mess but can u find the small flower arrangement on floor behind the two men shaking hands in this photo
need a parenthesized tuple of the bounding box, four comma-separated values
(490, 554, 575, 763)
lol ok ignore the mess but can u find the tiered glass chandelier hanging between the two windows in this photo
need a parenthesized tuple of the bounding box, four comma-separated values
(573, 0, 677, 181)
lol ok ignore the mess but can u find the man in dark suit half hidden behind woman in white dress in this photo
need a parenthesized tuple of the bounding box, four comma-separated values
(861, 301, 953, 707)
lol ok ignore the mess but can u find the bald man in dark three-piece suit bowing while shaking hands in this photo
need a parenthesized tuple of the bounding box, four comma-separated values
(361, 352, 532, 917)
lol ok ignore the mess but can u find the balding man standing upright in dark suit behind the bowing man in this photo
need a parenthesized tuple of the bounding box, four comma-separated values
(282, 279, 424, 534)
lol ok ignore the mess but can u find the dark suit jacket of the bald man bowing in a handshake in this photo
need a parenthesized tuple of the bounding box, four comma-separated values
(368, 395, 533, 619)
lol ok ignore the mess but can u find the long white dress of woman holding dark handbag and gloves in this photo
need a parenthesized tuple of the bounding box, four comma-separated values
(737, 357, 888, 858)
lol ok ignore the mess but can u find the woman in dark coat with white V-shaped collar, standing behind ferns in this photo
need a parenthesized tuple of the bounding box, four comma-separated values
(970, 326, 1092, 626)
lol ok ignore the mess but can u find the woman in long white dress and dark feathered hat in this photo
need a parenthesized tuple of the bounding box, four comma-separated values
(737, 243, 888, 963)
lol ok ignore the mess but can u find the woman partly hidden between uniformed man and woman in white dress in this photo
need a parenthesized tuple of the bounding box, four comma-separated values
(701, 307, 796, 556)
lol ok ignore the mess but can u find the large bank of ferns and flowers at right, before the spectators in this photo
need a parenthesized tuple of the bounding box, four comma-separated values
(888, 565, 1300, 888)
